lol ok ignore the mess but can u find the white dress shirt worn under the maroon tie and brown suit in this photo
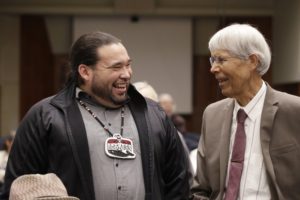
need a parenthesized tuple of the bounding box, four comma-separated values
(226, 82, 271, 200)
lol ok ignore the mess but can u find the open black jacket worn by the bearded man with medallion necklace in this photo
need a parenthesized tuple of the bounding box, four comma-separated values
(0, 85, 189, 200)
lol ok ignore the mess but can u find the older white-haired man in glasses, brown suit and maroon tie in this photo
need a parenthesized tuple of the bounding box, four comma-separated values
(192, 24, 300, 200)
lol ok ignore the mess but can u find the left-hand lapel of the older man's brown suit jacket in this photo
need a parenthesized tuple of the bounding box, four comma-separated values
(220, 101, 234, 195)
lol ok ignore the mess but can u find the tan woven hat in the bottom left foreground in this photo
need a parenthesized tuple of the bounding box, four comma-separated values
(9, 173, 79, 200)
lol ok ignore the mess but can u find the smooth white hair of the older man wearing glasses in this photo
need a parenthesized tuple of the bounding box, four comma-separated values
(208, 24, 271, 76)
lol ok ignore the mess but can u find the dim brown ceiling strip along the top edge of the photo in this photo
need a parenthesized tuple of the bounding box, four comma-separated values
(0, 0, 274, 16)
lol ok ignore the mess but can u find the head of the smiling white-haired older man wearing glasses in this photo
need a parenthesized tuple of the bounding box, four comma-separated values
(208, 24, 271, 105)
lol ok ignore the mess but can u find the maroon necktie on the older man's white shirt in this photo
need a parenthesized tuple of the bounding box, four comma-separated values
(224, 109, 247, 200)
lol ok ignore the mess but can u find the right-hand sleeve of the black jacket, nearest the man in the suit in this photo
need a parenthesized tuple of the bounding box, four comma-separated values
(163, 117, 190, 200)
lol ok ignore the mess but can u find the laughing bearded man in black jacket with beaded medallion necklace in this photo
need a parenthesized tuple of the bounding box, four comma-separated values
(1, 32, 189, 200)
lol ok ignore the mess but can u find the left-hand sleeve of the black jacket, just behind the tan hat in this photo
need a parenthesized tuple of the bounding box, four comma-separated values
(0, 102, 49, 199)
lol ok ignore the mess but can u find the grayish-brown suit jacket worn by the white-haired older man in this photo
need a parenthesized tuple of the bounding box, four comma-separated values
(192, 86, 300, 200)
